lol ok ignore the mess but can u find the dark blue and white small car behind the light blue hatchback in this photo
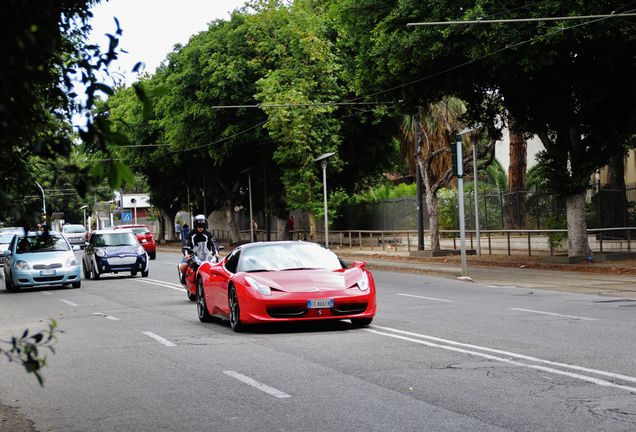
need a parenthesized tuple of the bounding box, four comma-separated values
(82, 229, 148, 279)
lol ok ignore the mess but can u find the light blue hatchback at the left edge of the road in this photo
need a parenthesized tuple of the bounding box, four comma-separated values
(3, 231, 81, 291)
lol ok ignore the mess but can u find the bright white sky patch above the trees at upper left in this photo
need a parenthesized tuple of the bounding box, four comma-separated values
(90, 0, 245, 85)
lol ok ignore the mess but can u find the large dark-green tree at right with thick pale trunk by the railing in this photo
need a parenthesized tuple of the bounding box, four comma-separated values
(334, 0, 636, 256)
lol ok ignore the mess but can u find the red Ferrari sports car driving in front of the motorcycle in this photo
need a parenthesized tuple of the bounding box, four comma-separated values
(191, 241, 376, 331)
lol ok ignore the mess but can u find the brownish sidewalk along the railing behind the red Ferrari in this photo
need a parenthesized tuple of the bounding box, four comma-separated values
(159, 243, 636, 299)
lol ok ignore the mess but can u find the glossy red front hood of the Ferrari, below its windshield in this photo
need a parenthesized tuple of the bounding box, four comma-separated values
(245, 268, 362, 292)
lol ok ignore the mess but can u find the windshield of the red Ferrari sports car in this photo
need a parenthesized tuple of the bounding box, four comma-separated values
(237, 243, 342, 272)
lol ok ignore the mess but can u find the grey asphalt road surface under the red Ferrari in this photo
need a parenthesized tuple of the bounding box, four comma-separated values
(0, 253, 636, 432)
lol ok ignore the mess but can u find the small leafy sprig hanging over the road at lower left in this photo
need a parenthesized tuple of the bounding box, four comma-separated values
(0, 319, 57, 387)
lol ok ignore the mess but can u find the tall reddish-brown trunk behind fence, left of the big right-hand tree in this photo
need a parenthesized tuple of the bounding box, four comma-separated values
(506, 119, 527, 229)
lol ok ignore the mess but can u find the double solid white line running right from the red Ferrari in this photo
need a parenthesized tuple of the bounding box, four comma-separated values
(366, 325, 636, 391)
